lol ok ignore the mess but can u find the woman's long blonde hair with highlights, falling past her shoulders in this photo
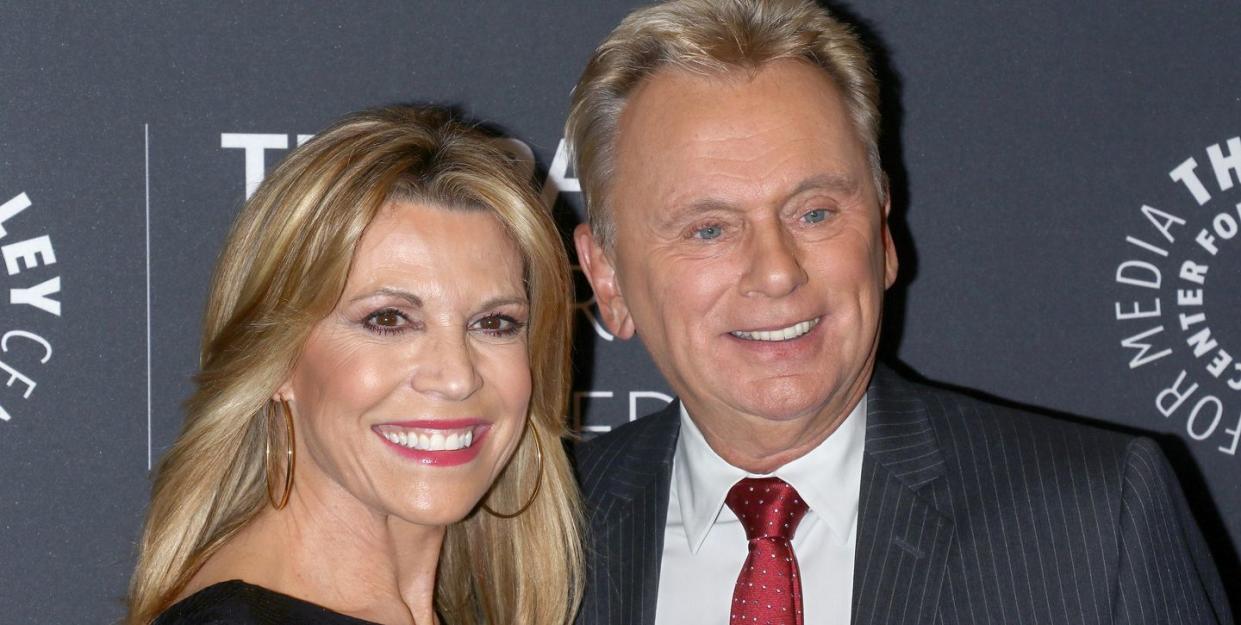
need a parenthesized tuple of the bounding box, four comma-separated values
(127, 107, 582, 625)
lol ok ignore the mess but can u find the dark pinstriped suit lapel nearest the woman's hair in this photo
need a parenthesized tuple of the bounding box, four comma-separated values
(591, 402, 680, 625)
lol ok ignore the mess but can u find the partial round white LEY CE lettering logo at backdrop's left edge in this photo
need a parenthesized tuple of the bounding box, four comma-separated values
(0, 191, 61, 428)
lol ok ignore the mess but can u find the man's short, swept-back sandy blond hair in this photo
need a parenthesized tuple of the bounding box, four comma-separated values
(565, 0, 886, 249)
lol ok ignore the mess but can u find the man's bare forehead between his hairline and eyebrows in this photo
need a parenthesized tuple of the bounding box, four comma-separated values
(612, 61, 871, 226)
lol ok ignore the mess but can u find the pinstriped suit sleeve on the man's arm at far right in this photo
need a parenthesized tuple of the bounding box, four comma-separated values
(1112, 439, 1232, 625)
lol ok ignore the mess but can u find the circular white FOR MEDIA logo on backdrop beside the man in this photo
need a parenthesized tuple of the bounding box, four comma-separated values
(1114, 136, 1241, 456)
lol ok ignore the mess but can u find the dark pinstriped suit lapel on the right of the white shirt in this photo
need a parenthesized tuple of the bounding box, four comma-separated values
(853, 367, 953, 625)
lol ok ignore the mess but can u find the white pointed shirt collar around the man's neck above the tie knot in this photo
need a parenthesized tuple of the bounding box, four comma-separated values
(673, 396, 866, 553)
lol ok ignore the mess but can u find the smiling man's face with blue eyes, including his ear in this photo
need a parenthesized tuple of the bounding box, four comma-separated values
(577, 61, 896, 466)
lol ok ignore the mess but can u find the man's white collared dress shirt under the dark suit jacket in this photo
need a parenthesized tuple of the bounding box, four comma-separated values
(655, 396, 866, 625)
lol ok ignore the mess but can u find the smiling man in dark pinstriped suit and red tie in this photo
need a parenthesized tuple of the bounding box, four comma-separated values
(567, 0, 1231, 625)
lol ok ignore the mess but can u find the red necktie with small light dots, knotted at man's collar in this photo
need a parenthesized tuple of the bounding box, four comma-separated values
(724, 477, 808, 625)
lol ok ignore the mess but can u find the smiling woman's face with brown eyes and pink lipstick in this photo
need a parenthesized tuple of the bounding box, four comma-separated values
(278, 202, 530, 526)
